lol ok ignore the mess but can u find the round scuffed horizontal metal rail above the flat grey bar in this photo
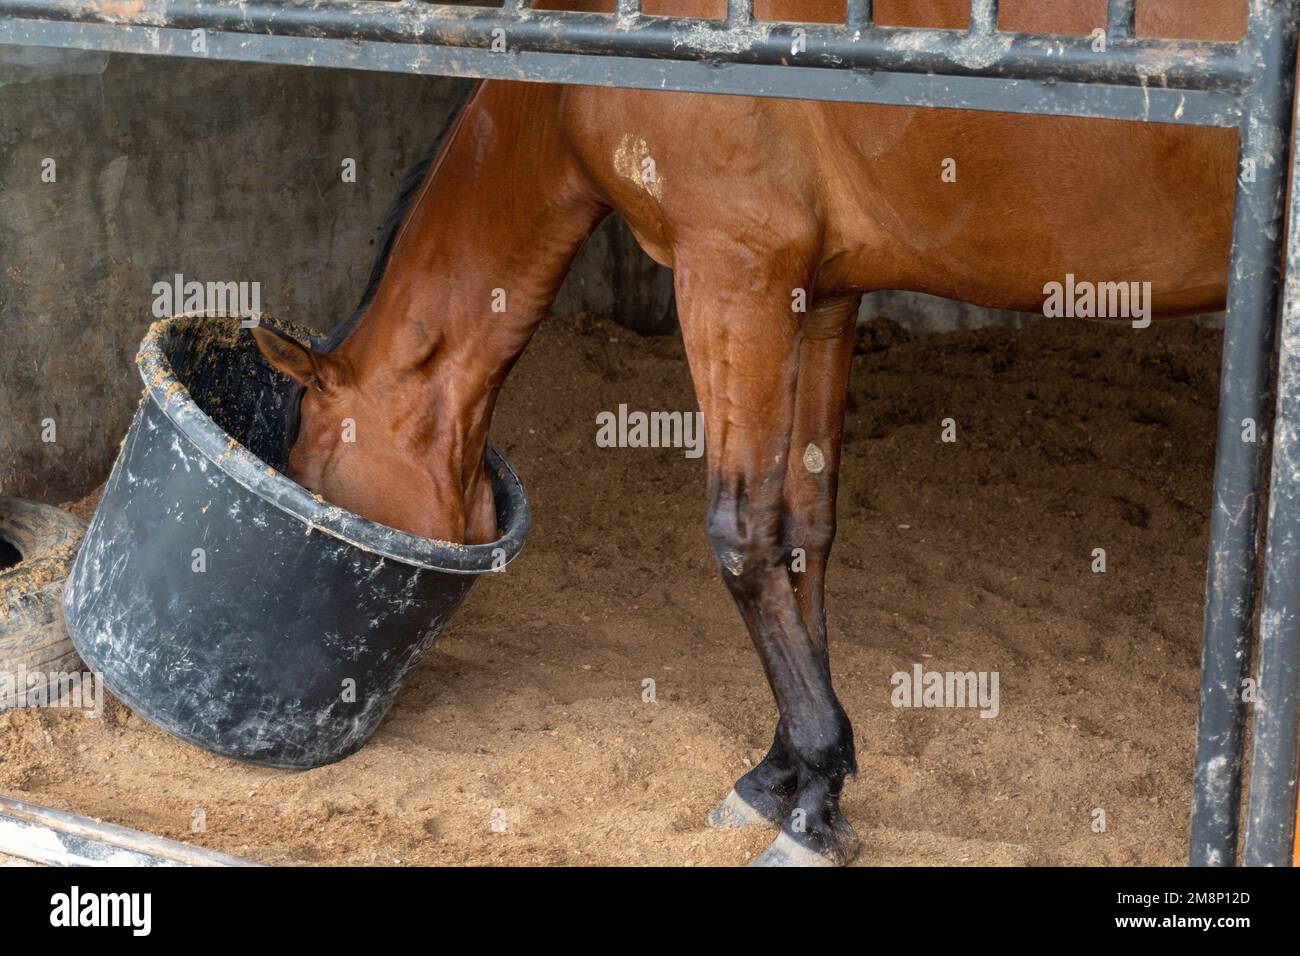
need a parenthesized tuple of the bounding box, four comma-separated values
(0, 0, 1258, 90)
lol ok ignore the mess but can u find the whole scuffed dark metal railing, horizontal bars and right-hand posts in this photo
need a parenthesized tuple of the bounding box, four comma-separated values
(0, 0, 1300, 865)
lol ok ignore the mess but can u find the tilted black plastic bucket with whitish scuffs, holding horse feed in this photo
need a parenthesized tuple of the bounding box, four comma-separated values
(64, 316, 530, 767)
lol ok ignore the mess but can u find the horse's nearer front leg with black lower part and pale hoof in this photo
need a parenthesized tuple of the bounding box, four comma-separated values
(677, 264, 857, 865)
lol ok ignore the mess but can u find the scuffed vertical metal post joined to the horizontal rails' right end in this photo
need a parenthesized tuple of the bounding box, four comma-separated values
(1190, 0, 1297, 866)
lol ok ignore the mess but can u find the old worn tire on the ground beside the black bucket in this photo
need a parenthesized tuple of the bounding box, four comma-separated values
(0, 496, 86, 711)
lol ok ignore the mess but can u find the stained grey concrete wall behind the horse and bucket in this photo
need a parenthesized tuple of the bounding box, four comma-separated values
(0, 47, 671, 499)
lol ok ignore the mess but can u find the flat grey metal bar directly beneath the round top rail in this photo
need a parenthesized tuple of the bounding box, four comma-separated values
(0, 18, 1242, 126)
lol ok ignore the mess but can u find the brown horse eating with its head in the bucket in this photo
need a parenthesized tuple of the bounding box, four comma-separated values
(256, 0, 1244, 864)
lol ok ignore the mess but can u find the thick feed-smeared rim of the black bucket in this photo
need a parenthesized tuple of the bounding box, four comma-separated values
(135, 312, 532, 575)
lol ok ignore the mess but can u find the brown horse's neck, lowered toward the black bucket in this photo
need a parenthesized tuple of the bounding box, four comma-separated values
(338, 83, 605, 486)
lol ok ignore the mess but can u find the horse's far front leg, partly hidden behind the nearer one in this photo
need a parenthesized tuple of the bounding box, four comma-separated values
(709, 295, 862, 842)
